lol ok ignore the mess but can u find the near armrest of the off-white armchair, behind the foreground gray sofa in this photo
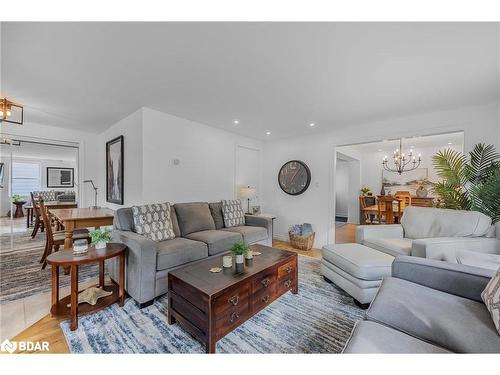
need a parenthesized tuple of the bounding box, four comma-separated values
(411, 237, 500, 263)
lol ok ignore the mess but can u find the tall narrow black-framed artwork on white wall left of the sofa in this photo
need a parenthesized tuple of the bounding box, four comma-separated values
(106, 135, 123, 204)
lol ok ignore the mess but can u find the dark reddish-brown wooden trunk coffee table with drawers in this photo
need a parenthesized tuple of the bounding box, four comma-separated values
(168, 245, 298, 353)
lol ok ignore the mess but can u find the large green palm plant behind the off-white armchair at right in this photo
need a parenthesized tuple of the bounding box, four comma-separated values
(432, 143, 500, 222)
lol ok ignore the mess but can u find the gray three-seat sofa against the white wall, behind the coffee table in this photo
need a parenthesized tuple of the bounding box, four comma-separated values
(108, 202, 272, 307)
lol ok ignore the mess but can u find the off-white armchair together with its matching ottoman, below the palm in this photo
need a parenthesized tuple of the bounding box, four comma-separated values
(321, 207, 500, 307)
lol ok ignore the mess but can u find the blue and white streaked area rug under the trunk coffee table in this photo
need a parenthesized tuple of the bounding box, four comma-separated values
(61, 255, 364, 353)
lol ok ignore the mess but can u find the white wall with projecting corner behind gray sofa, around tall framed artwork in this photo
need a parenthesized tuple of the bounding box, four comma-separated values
(94, 108, 263, 209)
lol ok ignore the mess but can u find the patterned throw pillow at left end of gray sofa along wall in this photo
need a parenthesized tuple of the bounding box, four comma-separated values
(132, 203, 175, 241)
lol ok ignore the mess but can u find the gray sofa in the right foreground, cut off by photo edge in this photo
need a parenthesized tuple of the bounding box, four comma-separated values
(344, 256, 500, 353)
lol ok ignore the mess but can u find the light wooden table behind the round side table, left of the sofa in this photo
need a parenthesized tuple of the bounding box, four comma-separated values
(49, 208, 114, 249)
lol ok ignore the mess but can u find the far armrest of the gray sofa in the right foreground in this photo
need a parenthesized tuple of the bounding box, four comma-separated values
(392, 256, 495, 302)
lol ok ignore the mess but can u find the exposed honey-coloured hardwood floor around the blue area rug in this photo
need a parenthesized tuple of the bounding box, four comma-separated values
(5, 224, 356, 354)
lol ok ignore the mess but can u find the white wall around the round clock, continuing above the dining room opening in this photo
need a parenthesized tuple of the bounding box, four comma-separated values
(263, 104, 500, 246)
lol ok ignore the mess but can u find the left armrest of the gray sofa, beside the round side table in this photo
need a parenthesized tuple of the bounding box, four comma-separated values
(110, 230, 158, 303)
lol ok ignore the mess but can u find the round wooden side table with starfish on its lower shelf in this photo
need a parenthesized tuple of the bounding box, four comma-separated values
(47, 243, 127, 331)
